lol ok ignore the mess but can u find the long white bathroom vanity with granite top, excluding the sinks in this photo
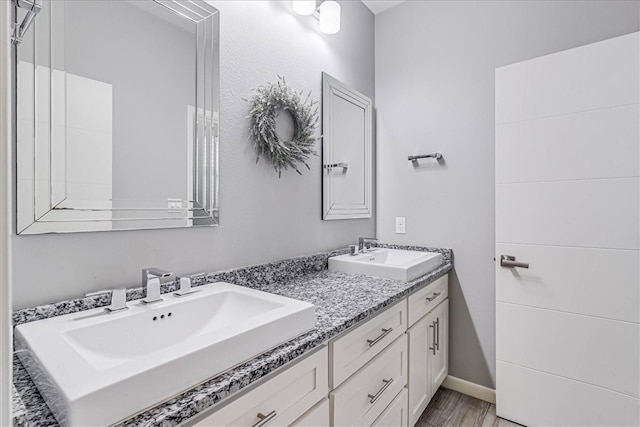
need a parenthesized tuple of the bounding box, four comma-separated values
(14, 245, 452, 426)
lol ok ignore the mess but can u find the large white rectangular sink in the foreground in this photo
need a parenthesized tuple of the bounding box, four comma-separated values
(16, 283, 315, 426)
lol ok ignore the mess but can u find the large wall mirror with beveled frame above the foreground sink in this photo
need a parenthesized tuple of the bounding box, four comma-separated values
(14, 0, 220, 234)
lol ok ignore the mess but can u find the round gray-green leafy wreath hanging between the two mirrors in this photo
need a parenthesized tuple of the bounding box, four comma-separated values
(248, 76, 318, 178)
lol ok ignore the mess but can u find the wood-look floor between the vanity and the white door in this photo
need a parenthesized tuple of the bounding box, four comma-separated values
(415, 387, 520, 427)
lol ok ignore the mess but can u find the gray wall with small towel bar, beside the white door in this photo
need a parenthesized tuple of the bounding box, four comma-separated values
(376, 1, 640, 387)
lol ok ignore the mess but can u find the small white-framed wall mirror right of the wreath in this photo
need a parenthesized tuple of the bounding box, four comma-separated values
(322, 73, 373, 220)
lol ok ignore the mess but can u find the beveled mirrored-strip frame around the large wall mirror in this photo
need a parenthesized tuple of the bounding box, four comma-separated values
(12, 0, 220, 234)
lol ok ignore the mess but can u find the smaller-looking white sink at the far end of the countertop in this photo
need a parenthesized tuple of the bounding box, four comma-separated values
(329, 248, 442, 282)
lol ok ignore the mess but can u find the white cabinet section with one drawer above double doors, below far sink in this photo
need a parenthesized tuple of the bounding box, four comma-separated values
(407, 276, 449, 426)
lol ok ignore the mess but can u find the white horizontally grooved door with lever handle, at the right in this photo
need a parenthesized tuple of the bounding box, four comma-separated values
(496, 33, 640, 426)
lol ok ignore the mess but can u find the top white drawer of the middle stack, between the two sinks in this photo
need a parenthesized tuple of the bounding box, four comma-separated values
(329, 299, 407, 388)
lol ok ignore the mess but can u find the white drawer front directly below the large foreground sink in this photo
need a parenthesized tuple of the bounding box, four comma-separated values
(196, 347, 329, 426)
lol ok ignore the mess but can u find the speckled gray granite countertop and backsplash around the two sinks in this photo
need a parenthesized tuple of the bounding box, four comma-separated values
(14, 244, 453, 427)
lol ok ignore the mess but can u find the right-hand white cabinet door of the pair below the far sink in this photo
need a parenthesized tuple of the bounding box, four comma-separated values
(427, 299, 449, 396)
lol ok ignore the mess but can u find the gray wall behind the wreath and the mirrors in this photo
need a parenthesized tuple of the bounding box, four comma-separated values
(12, 1, 375, 308)
